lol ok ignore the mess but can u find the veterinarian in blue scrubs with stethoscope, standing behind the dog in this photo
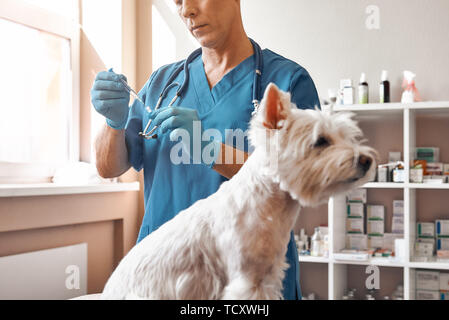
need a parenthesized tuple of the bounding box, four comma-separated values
(91, 0, 320, 299)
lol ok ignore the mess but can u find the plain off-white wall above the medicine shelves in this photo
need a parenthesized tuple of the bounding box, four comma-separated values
(241, 0, 449, 102)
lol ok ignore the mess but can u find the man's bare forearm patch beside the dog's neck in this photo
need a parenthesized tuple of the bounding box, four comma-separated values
(213, 144, 249, 179)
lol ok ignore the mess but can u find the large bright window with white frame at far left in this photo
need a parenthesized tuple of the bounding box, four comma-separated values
(0, 0, 79, 183)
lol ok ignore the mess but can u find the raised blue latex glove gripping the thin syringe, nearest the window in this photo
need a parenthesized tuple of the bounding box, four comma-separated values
(90, 69, 129, 130)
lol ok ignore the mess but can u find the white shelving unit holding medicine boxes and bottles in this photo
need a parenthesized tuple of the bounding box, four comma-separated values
(299, 101, 449, 300)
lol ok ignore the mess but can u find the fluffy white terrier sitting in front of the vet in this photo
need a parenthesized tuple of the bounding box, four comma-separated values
(102, 84, 377, 300)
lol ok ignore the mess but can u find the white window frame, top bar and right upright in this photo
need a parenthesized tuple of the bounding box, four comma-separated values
(0, 0, 80, 168)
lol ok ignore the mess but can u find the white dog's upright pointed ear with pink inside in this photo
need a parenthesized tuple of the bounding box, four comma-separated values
(262, 83, 290, 129)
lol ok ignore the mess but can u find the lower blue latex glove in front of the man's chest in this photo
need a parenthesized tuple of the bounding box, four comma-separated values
(150, 107, 221, 168)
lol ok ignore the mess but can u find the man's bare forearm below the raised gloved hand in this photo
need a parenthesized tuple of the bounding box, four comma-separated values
(95, 125, 131, 178)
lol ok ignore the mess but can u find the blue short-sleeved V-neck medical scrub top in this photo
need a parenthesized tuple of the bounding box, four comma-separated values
(125, 49, 320, 300)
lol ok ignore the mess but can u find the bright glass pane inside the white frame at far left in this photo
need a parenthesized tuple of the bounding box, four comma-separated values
(0, 19, 72, 163)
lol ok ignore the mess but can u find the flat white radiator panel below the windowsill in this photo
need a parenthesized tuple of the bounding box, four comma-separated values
(0, 243, 87, 300)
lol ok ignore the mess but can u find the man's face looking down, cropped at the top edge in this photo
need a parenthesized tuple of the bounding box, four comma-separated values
(173, 0, 240, 48)
